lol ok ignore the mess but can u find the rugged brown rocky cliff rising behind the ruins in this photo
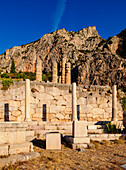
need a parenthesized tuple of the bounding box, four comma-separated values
(0, 26, 126, 86)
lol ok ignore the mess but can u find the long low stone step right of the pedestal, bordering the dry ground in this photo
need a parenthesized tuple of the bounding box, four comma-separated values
(88, 134, 122, 141)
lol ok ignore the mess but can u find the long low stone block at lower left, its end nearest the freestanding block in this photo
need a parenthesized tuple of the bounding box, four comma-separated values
(9, 142, 33, 155)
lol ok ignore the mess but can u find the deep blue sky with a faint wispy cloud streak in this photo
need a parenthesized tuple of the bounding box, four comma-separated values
(0, 0, 126, 54)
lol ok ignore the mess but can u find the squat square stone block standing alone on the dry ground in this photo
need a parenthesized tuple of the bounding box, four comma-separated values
(46, 132, 61, 150)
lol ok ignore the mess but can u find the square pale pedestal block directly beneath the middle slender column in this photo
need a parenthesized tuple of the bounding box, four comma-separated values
(72, 120, 87, 138)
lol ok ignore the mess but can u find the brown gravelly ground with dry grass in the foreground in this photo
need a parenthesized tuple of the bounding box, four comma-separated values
(2, 142, 126, 170)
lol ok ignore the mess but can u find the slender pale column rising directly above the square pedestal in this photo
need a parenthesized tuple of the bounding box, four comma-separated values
(72, 83, 77, 120)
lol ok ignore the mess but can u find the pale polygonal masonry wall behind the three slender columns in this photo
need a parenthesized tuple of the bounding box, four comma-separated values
(0, 81, 123, 121)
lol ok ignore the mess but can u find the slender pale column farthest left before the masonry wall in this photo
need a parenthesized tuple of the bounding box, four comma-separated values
(25, 79, 31, 121)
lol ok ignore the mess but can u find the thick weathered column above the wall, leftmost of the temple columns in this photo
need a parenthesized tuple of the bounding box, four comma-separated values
(36, 60, 42, 81)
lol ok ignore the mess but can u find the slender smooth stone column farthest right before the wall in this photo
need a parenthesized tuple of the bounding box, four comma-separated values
(112, 85, 117, 121)
